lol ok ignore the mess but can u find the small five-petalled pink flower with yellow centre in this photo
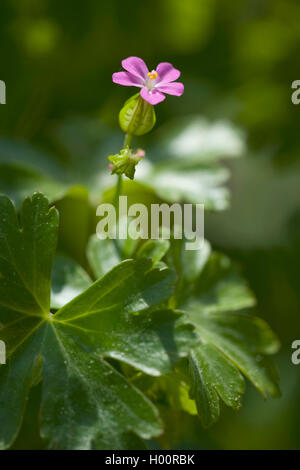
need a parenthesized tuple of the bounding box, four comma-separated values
(112, 57, 184, 105)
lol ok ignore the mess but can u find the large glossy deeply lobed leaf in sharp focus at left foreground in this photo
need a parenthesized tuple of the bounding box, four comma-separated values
(0, 194, 196, 449)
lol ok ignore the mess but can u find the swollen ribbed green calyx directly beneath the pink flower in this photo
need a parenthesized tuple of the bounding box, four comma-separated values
(119, 93, 156, 135)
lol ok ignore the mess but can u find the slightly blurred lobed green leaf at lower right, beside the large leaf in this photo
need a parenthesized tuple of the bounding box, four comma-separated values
(180, 253, 280, 427)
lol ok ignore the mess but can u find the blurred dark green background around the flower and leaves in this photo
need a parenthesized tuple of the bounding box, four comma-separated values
(0, 0, 300, 449)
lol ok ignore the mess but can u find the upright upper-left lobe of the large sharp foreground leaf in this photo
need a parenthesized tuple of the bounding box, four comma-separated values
(0, 193, 58, 323)
